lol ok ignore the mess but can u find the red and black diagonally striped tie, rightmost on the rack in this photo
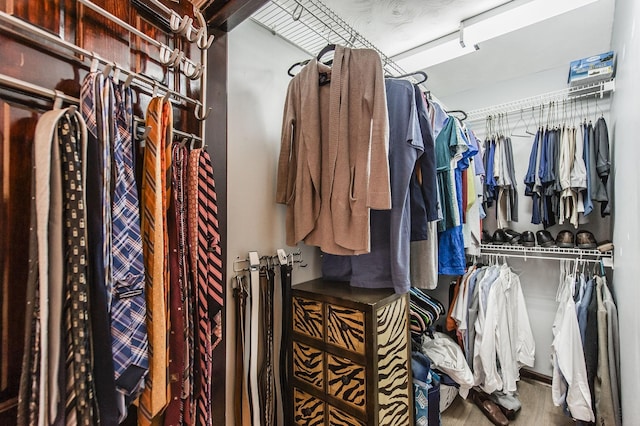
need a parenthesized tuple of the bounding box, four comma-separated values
(191, 150, 223, 425)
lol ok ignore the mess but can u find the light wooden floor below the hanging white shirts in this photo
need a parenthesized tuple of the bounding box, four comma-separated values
(442, 378, 575, 426)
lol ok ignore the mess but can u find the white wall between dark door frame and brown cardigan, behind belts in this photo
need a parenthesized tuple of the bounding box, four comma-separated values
(225, 20, 321, 425)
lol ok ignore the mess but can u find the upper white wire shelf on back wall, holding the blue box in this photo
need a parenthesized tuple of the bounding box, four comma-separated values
(467, 80, 615, 121)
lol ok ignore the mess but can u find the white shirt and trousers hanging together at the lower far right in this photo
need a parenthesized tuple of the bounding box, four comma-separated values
(552, 262, 621, 425)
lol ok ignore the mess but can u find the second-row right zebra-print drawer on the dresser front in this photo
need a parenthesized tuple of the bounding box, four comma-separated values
(327, 354, 367, 410)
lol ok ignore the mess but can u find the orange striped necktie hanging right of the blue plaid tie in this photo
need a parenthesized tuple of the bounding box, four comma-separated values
(138, 97, 173, 425)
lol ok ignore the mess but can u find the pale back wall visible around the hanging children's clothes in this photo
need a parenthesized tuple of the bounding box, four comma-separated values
(433, 62, 611, 376)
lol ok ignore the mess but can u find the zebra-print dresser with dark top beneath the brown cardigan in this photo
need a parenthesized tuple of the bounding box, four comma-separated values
(289, 279, 413, 426)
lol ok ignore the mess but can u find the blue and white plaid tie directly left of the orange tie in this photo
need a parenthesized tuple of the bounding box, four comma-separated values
(111, 79, 149, 401)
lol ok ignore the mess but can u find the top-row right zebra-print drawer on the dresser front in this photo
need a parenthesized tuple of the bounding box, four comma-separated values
(327, 304, 365, 354)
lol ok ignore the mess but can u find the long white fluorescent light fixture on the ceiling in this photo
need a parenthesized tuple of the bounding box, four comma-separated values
(391, 0, 597, 70)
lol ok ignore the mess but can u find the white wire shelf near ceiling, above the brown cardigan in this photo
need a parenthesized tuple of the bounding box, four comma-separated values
(251, 0, 406, 75)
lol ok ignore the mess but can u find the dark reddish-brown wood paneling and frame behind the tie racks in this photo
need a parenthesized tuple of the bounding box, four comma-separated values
(0, 0, 233, 425)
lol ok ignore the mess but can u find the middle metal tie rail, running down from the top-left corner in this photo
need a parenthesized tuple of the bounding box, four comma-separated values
(0, 10, 202, 107)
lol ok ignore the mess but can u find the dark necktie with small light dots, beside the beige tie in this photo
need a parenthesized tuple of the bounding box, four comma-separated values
(58, 111, 98, 426)
